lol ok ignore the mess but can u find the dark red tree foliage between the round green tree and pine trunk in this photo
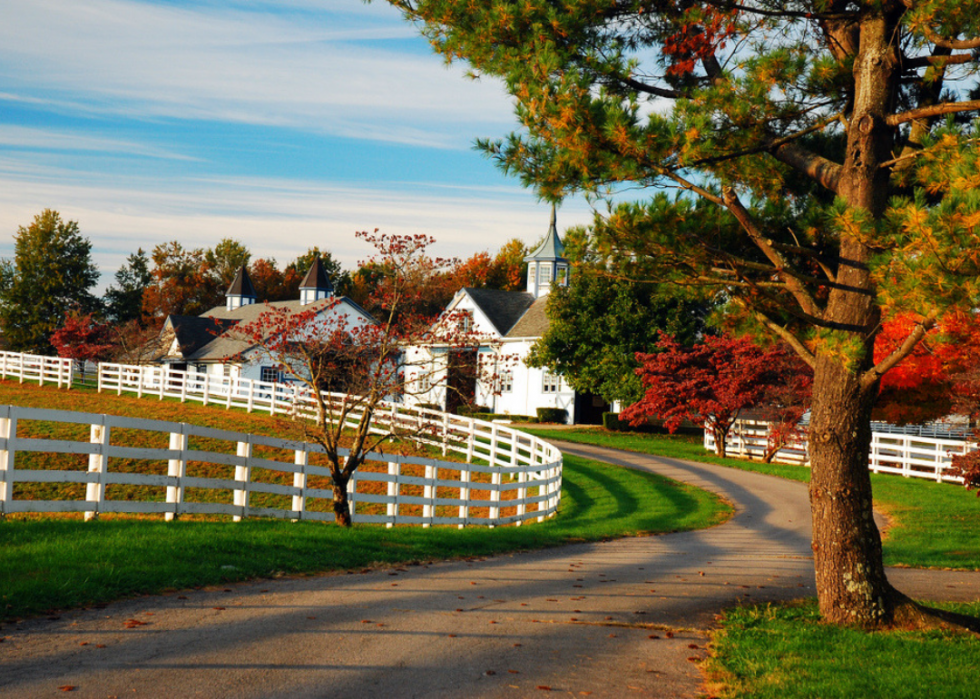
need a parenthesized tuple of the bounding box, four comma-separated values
(621, 335, 812, 454)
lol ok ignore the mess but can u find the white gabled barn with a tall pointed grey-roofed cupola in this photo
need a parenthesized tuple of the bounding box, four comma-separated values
(405, 210, 605, 423)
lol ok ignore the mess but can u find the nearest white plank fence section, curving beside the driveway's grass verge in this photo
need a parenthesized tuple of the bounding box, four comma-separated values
(0, 405, 562, 527)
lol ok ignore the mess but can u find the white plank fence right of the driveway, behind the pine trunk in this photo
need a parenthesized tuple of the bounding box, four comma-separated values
(704, 420, 977, 483)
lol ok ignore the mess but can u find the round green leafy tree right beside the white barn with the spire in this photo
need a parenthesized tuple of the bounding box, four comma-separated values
(527, 236, 711, 404)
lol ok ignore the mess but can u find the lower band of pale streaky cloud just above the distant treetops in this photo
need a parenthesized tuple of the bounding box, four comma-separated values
(0, 159, 591, 284)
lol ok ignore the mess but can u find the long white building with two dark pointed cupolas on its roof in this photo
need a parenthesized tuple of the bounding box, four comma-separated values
(156, 258, 375, 381)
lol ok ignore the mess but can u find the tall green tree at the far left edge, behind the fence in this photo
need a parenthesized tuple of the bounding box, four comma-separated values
(0, 209, 99, 354)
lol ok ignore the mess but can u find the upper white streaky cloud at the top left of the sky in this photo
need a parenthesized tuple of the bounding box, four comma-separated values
(0, 0, 513, 147)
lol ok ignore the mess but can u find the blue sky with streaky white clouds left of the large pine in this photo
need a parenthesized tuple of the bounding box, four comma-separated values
(0, 0, 592, 289)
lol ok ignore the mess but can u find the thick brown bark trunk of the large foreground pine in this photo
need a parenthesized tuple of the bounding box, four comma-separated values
(809, 0, 904, 628)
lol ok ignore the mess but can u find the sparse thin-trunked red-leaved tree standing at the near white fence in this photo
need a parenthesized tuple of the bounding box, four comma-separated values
(233, 232, 494, 526)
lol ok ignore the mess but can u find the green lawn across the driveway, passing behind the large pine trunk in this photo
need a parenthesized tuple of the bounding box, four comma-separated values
(526, 428, 980, 570)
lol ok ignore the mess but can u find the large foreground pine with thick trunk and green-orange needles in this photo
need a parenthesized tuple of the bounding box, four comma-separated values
(390, 0, 980, 627)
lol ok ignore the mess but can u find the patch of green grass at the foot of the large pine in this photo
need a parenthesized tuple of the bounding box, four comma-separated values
(708, 601, 980, 699)
